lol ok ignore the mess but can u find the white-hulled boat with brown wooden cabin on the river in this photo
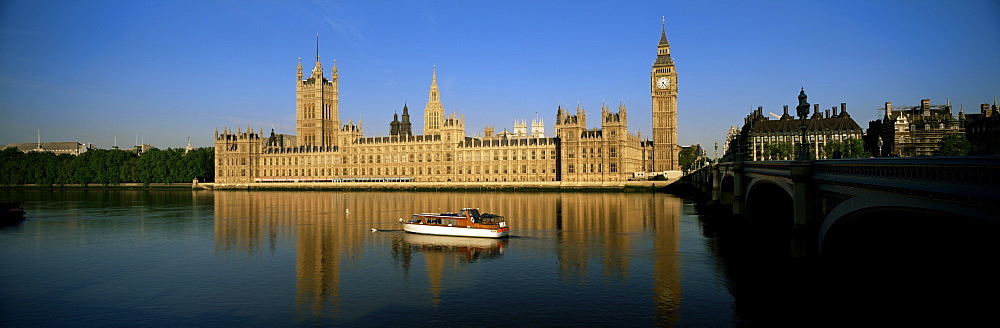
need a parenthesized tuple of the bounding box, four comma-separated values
(399, 208, 510, 238)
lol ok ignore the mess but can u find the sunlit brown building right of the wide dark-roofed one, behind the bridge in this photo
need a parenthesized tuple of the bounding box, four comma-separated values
(866, 99, 965, 157)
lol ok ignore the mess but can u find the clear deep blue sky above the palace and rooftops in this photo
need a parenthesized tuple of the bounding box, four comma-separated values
(0, 0, 1000, 155)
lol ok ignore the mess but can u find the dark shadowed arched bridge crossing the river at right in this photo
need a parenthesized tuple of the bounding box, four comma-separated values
(680, 156, 1000, 261)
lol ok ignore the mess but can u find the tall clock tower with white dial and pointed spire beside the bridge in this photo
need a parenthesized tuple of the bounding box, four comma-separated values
(649, 18, 680, 172)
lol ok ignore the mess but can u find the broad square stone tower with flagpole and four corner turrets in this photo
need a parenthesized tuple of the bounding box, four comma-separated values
(295, 38, 340, 146)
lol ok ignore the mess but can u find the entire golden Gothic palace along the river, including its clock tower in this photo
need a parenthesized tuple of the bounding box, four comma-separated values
(215, 26, 680, 185)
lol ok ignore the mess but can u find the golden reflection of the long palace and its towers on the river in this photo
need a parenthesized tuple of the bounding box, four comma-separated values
(214, 191, 682, 325)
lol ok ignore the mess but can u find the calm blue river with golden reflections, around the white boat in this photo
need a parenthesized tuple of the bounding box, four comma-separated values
(0, 189, 988, 327)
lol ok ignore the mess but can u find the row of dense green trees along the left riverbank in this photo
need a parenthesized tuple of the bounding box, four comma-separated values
(0, 148, 215, 186)
